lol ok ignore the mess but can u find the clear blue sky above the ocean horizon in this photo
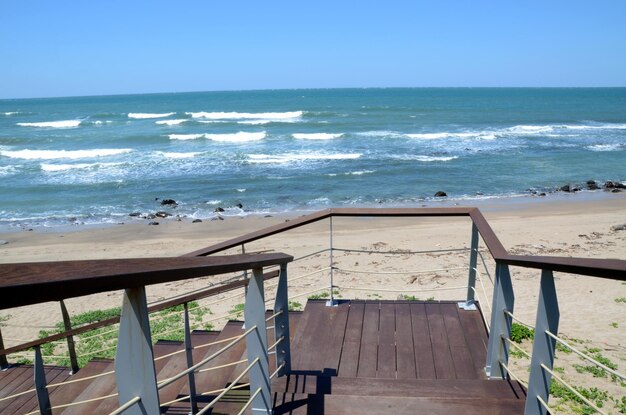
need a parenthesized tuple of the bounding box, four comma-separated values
(0, 0, 626, 98)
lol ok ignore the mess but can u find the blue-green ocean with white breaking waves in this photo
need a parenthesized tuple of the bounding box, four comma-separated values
(0, 88, 626, 227)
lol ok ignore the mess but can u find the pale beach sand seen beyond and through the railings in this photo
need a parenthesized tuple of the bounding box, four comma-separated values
(0, 193, 626, 412)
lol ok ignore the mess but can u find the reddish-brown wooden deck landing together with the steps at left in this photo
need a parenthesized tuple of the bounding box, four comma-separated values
(0, 300, 525, 415)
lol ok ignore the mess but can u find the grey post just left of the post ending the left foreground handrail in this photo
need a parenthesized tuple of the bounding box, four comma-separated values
(244, 268, 272, 414)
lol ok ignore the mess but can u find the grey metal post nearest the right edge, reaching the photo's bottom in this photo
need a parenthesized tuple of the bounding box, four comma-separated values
(524, 270, 560, 415)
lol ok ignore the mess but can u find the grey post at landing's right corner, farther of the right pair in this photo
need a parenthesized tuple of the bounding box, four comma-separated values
(485, 264, 515, 379)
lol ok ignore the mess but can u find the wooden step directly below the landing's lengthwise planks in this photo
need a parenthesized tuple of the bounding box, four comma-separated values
(272, 374, 526, 399)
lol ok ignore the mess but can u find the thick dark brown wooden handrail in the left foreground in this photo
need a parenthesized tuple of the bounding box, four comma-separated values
(0, 253, 293, 309)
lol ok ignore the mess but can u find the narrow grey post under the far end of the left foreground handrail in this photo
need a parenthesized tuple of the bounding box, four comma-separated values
(274, 264, 291, 376)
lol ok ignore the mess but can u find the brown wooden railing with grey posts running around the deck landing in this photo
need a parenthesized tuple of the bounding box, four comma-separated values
(0, 207, 626, 414)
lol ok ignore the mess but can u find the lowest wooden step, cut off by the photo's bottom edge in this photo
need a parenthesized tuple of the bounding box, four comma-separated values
(273, 394, 524, 415)
